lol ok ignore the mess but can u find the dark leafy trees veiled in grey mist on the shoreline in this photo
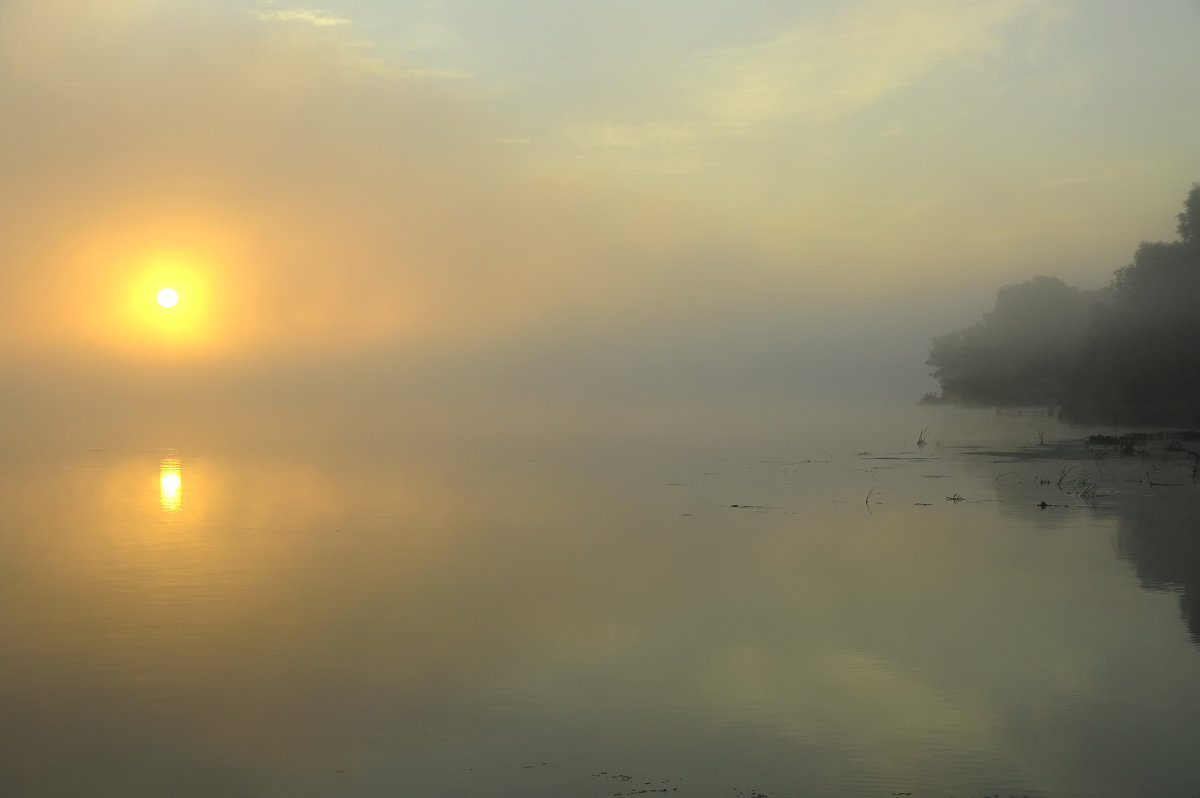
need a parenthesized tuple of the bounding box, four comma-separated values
(926, 184, 1200, 425)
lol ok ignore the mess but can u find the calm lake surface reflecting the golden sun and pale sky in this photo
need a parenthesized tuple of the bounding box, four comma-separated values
(0, 408, 1200, 798)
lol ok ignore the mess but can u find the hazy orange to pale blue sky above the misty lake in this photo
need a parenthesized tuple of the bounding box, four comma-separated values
(0, 0, 1200, 429)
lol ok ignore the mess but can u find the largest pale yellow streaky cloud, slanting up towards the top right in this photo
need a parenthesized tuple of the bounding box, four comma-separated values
(552, 0, 1042, 164)
